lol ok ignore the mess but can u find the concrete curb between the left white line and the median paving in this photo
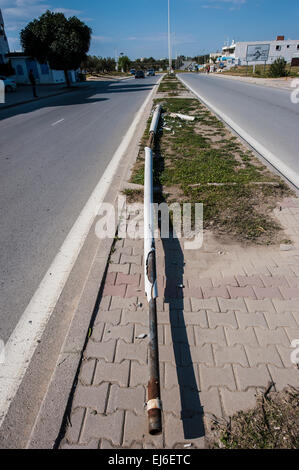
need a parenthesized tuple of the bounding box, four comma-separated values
(26, 75, 164, 449)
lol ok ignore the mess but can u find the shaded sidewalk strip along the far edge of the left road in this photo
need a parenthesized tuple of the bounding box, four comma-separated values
(0, 82, 89, 111)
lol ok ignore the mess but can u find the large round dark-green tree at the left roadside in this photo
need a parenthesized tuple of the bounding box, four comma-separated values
(20, 10, 92, 87)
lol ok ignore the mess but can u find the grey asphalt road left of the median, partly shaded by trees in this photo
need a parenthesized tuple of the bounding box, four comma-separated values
(0, 77, 158, 341)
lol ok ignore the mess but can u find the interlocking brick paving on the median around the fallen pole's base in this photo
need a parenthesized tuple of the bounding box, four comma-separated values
(60, 199, 299, 449)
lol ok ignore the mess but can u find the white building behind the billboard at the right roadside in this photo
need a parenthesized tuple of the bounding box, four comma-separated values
(222, 36, 299, 65)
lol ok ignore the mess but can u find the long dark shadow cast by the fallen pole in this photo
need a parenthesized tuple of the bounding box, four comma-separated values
(154, 118, 205, 439)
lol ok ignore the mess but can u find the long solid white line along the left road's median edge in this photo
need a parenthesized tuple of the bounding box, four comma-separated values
(0, 76, 163, 426)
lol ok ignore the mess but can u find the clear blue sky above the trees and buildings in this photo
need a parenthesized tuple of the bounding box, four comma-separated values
(0, 0, 299, 59)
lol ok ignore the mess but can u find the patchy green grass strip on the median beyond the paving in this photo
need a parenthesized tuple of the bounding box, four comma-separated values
(131, 72, 291, 244)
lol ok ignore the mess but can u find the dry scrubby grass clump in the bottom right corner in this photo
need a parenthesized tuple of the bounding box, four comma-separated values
(209, 388, 299, 449)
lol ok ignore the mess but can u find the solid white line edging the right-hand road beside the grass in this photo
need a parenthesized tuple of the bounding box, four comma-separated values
(178, 77, 299, 188)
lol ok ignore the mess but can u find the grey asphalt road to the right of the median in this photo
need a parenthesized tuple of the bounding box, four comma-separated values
(181, 74, 299, 182)
